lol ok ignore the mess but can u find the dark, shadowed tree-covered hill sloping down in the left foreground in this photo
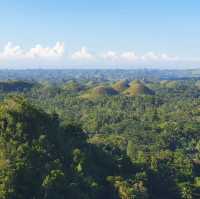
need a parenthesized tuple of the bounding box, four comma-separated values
(0, 98, 142, 199)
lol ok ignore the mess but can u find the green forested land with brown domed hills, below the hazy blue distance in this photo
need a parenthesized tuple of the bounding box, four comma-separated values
(0, 74, 200, 199)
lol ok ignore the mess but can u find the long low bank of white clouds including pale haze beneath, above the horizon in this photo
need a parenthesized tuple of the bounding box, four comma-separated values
(0, 41, 196, 67)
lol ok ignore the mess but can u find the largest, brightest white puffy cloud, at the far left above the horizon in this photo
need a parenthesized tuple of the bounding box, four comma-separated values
(0, 42, 65, 60)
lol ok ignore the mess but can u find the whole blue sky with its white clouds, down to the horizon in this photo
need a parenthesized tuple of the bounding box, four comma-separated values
(0, 0, 200, 69)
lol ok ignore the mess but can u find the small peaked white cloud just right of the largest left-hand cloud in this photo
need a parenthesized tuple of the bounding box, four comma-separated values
(71, 47, 94, 60)
